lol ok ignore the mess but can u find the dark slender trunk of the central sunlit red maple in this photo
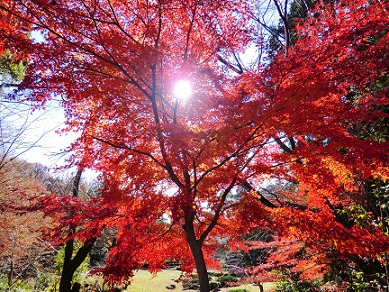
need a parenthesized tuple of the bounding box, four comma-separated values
(184, 220, 211, 292)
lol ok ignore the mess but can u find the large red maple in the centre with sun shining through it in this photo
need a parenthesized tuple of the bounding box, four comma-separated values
(0, 0, 388, 291)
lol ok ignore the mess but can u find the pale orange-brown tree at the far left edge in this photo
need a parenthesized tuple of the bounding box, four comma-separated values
(0, 159, 53, 288)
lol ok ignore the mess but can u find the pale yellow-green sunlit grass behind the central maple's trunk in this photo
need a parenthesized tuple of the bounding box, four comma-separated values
(126, 270, 273, 292)
